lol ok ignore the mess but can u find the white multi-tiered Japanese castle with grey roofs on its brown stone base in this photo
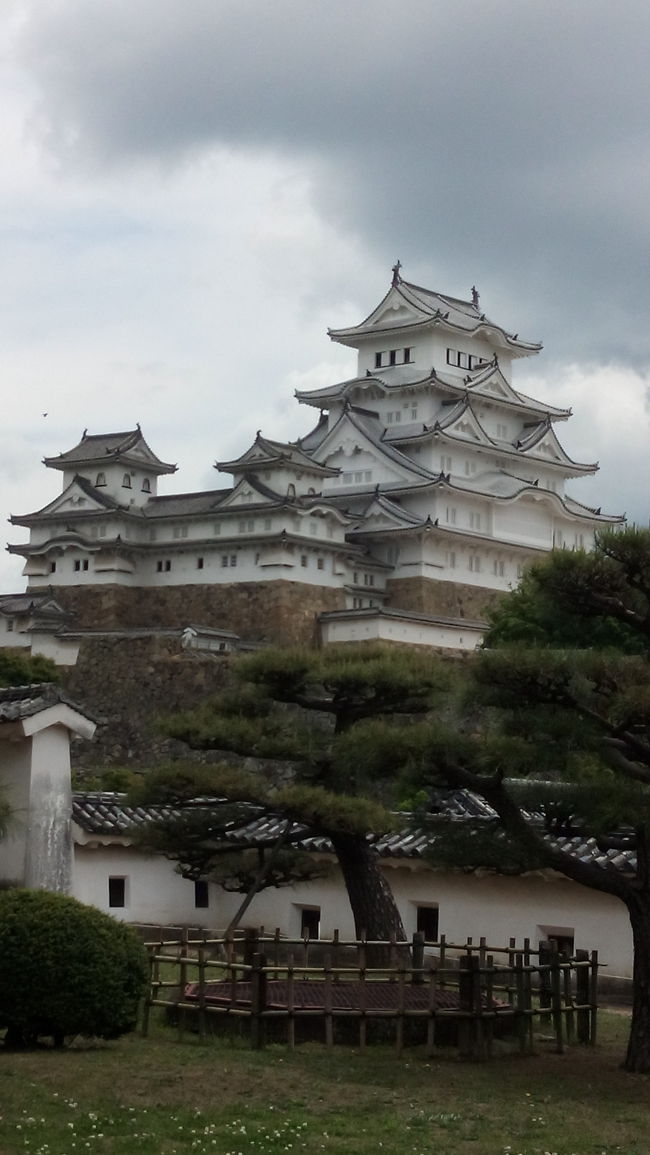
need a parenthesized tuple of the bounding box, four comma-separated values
(6, 263, 622, 649)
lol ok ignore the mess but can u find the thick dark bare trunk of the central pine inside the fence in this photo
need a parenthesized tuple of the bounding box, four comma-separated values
(330, 834, 405, 966)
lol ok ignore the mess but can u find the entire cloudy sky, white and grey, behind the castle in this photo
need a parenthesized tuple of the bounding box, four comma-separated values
(0, 0, 650, 591)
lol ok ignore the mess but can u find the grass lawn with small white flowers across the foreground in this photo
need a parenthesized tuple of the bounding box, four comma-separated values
(0, 1015, 650, 1155)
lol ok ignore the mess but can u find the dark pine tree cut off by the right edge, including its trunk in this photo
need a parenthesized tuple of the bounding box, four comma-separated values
(413, 529, 650, 1071)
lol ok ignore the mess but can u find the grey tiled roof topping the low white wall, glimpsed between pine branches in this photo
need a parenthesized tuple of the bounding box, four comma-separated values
(73, 790, 636, 873)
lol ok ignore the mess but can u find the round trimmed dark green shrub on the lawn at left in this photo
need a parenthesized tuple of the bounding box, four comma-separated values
(0, 889, 147, 1046)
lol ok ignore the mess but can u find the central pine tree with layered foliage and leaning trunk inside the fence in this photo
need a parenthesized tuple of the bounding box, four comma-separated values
(139, 647, 454, 939)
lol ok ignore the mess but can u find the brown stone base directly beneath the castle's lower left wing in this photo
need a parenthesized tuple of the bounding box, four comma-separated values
(54, 581, 345, 646)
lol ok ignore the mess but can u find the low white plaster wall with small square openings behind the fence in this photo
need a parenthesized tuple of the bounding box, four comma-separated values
(69, 845, 633, 977)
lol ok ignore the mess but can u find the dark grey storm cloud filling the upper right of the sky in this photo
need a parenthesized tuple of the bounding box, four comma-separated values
(16, 0, 650, 365)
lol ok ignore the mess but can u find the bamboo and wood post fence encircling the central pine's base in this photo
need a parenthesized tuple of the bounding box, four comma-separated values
(142, 929, 598, 1059)
